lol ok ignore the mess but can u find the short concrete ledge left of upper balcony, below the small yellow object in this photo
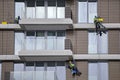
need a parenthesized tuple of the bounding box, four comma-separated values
(0, 24, 21, 29)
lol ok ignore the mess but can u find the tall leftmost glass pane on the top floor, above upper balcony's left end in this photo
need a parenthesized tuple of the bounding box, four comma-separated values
(15, 2, 25, 19)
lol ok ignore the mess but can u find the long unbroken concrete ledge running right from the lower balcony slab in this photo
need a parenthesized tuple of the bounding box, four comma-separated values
(73, 54, 120, 60)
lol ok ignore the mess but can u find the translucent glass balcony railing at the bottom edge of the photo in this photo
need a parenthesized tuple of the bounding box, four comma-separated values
(10, 71, 57, 80)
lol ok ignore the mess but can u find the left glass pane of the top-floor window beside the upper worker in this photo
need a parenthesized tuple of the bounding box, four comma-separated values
(78, 2, 87, 23)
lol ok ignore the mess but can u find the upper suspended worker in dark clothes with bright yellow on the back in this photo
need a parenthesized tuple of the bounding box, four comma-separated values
(94, 16, 106, 36)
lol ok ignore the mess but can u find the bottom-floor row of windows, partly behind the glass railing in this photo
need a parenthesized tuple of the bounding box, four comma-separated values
(13, 61, 66, 80)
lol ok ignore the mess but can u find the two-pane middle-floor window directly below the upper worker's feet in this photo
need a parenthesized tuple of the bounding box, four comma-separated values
(88, 32, 108, 54)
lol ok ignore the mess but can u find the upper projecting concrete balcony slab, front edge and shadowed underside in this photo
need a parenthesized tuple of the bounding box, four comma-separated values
(19, 18, 73, 30)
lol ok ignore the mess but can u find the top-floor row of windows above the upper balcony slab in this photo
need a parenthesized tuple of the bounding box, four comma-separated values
(15, 0, 65, 19)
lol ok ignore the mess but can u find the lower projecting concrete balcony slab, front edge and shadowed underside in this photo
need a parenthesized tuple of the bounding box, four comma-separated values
(19, 50, 72, 61)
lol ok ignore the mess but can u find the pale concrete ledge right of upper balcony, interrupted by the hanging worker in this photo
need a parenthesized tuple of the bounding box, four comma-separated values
(73, 23, 120, 29)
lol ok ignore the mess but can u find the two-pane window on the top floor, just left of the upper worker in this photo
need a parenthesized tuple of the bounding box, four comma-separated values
(78, 0, 97, 23)
